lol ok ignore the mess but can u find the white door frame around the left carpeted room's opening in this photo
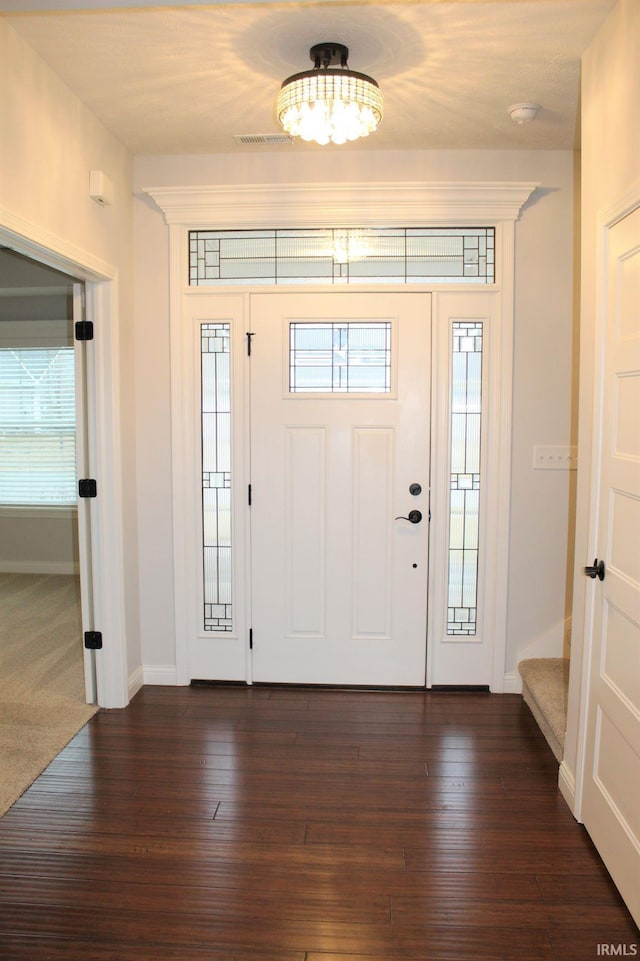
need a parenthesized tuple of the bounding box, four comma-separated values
(0, 207, 129, 707)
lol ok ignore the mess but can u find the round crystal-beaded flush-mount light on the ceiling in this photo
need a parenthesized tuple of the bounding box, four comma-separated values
(277, 43, 382, 144)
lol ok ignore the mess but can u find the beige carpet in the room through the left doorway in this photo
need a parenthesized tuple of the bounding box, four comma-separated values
(0, 574, 97, 816)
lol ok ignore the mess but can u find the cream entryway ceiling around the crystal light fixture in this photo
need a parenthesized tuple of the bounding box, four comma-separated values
(0, 0, 615, 154)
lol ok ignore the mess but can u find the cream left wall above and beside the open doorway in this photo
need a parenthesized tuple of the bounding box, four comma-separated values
(0, 19, 140, 688)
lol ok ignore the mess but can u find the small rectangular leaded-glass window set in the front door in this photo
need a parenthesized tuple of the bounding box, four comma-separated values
(289, 321, 391, 394)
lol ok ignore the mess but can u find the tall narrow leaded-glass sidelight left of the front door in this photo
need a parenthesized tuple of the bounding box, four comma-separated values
(201, 323, 233, 632)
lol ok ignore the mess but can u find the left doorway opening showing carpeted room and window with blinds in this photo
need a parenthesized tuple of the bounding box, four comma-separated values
(0, 248, 96, 812)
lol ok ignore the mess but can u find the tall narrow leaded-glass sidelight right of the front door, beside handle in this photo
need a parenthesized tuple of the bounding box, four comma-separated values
(447, 321, 482, 636)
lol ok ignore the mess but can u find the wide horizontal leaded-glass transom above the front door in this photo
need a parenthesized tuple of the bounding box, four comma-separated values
(189, 227, 495, 287)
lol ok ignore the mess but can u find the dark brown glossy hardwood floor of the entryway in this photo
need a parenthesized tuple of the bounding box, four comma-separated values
(0, 687, 640, 961)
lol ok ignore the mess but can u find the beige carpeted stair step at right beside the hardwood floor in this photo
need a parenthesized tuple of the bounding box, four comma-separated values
(518, 657, 569, 761)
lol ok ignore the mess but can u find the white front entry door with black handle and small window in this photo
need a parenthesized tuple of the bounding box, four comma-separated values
(251, 292, 431, 686)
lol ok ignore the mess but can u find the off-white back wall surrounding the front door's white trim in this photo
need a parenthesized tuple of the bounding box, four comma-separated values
(134, 148, 574, 676)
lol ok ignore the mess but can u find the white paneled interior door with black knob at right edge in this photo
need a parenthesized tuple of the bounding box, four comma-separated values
(582, 201, 640, 922)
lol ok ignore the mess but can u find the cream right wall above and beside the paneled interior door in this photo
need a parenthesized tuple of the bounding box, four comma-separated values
(564, 0, 640, 780)
